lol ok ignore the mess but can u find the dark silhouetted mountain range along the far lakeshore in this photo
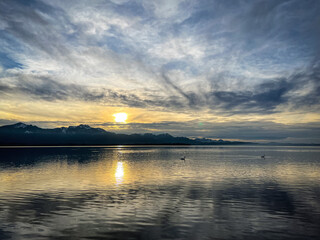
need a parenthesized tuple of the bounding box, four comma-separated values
(0, 123, 249, 146)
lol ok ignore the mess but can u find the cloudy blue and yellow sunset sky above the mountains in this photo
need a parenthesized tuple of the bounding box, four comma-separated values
(0, 0, 320, 143)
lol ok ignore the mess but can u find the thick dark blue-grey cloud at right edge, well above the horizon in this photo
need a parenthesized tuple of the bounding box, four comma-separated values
(207, 64, 320, 114)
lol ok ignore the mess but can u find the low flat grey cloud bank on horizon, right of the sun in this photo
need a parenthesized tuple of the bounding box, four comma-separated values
(97, 121, 320, 143)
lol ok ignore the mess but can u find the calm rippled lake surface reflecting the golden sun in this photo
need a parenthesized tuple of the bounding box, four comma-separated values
(0, 146, 320, 240)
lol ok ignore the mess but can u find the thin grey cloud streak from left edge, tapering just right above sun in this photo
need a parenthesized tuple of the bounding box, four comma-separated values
(0, 75, 188, 110)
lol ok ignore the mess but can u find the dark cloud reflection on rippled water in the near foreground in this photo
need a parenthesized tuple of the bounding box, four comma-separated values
(0, 181, 320, 239)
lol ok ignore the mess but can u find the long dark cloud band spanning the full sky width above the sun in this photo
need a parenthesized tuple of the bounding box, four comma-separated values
(0, 60, 320, 115)
